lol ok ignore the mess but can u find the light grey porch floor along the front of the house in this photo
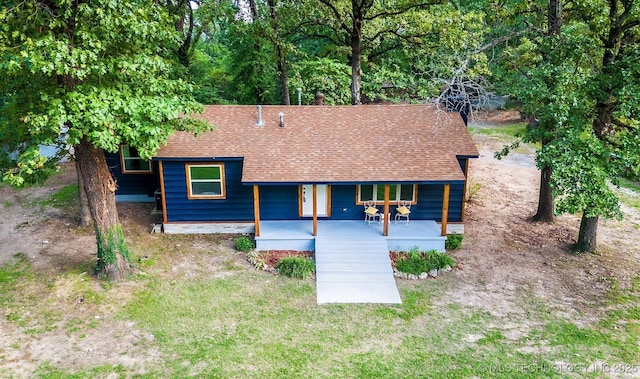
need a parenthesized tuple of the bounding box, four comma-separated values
(256, 220, 446, 251)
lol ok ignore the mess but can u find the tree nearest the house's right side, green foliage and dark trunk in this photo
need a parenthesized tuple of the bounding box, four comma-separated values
(496, 0, 594, 226)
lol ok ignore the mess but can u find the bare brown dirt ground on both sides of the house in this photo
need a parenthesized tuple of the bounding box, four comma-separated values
(0, 113, 640, 377)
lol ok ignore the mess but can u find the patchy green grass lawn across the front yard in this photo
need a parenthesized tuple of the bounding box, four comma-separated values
(0, 245, 640, 378)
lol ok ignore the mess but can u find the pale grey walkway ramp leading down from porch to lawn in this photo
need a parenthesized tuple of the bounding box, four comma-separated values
(315, 235, 401, 304)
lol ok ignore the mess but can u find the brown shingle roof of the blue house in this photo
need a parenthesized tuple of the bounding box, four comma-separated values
(157, 105, 478, 183)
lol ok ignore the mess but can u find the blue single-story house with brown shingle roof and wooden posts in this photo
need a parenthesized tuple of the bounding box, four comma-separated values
(107, 104, 478, 252)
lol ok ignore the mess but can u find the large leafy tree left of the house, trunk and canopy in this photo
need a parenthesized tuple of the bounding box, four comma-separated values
(0, 0, 207, 280)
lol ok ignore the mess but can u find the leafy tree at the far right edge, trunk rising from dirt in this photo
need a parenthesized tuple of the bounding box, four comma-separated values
(524, 0, 640, 252)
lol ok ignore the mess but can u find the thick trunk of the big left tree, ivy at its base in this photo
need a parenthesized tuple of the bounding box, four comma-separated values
(75, 139, 131, 281)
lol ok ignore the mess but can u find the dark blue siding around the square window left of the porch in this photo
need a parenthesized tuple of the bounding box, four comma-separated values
(162, 161, 254, 222)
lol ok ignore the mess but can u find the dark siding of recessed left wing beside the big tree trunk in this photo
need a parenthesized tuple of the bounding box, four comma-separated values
(104, 153, 160, 197)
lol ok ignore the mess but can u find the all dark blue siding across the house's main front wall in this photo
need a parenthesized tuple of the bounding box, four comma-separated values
(157, 160, 464, 222)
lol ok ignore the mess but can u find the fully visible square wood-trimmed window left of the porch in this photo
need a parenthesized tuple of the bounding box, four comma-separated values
(186, 164, 225, 199)
